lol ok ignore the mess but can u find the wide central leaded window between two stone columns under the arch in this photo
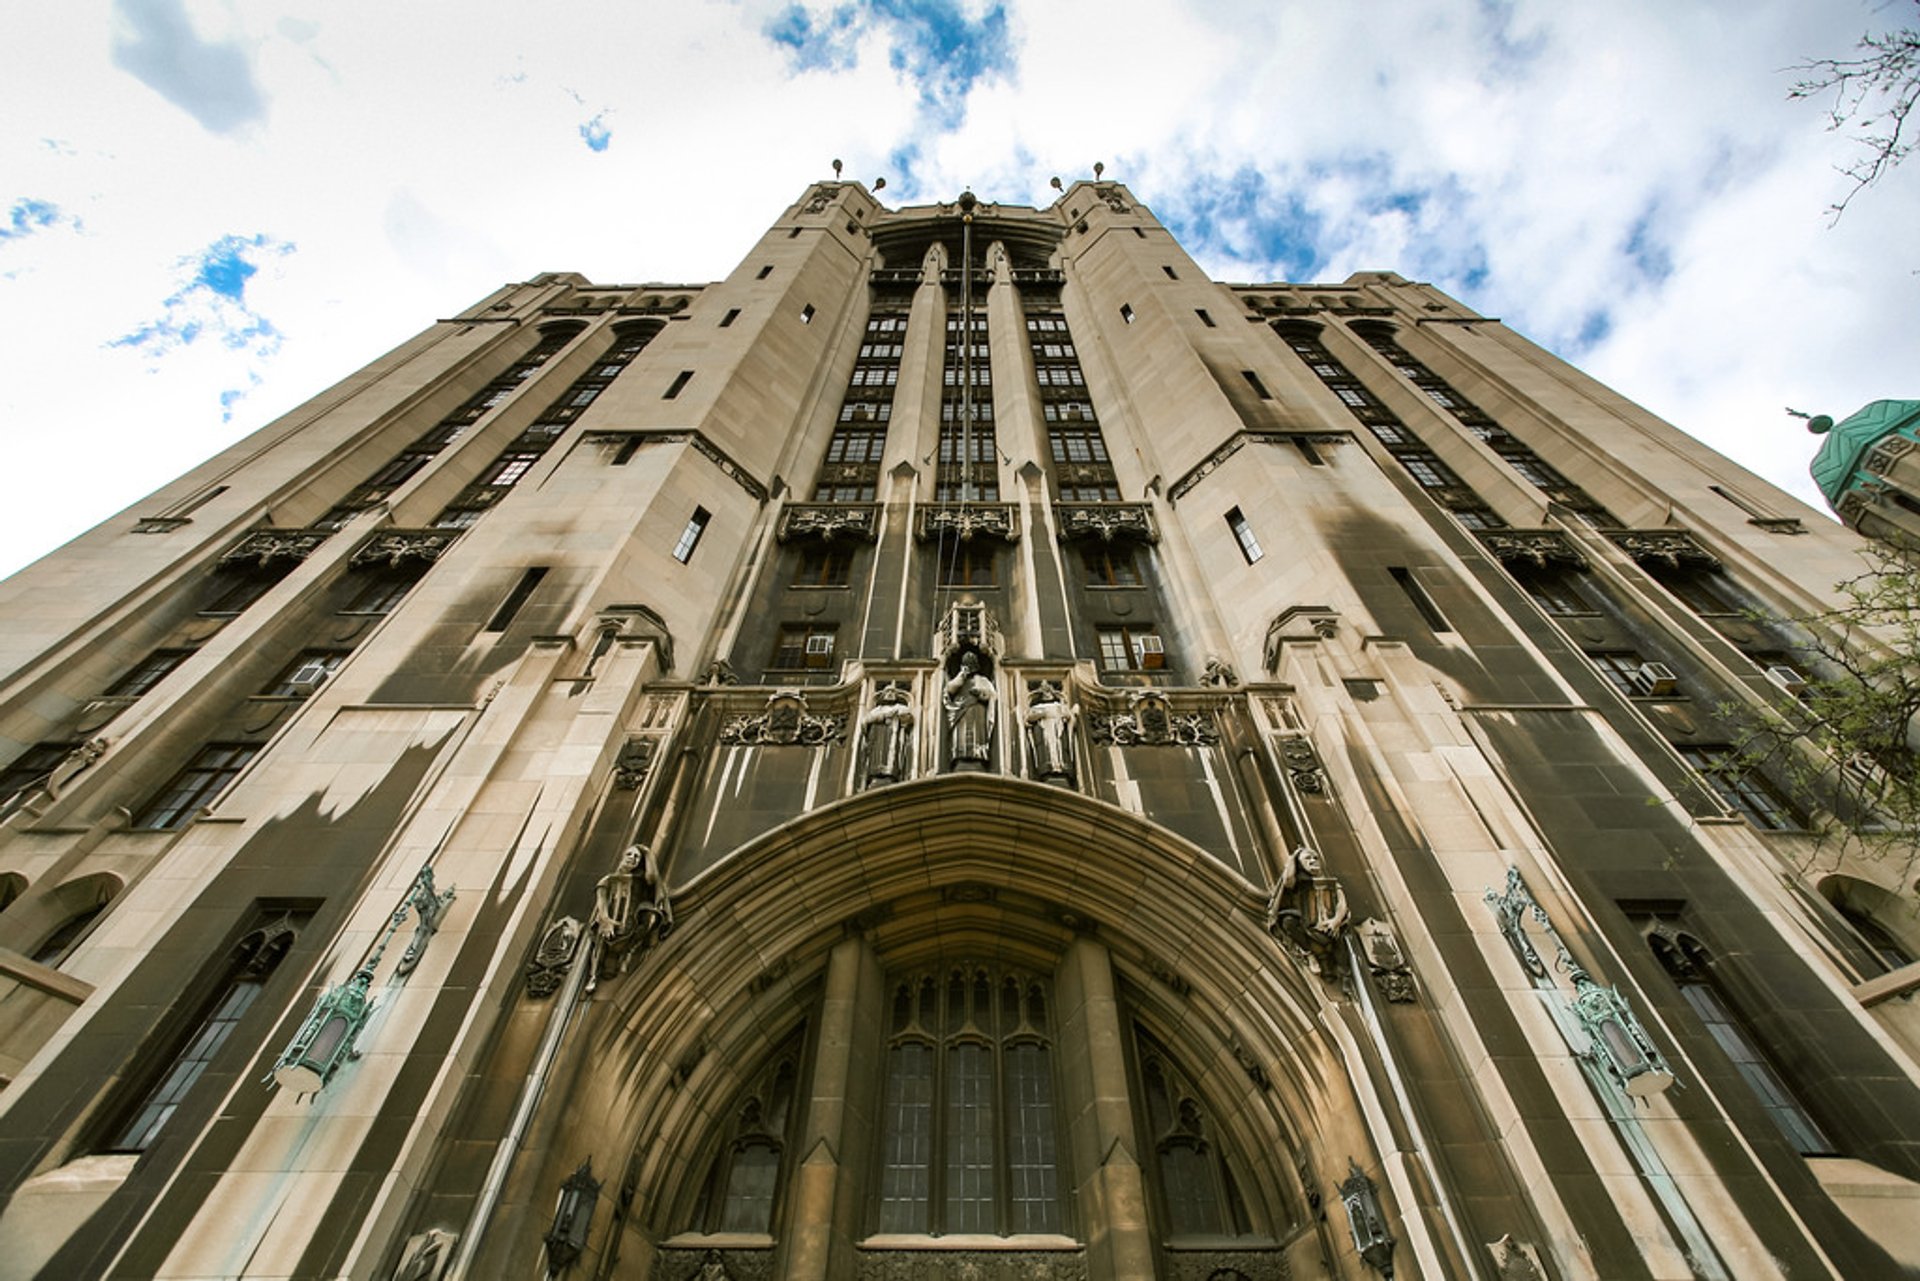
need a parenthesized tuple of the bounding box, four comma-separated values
(876, 964, 1066, 1235)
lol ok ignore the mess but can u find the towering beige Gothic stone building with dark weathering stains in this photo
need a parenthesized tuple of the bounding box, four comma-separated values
(0, 182, 1920, 1281)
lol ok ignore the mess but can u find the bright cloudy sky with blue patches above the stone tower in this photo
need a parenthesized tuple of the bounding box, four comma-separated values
(0, 0, 1920, 572)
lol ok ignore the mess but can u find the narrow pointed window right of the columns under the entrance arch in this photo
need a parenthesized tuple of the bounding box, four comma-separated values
(1133, 1026, 1252, 1237)
